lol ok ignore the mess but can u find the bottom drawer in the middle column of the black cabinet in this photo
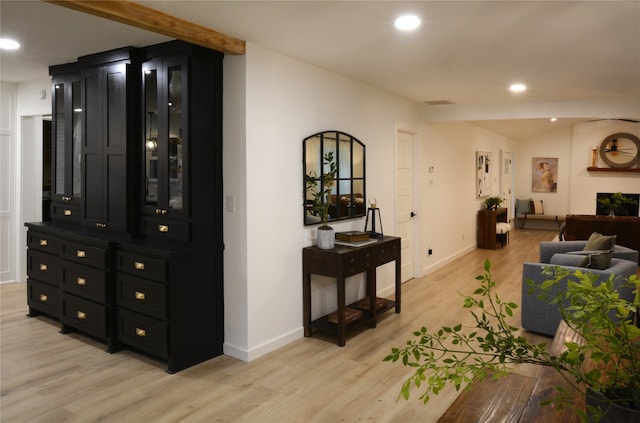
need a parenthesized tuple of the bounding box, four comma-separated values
(60, 293, 108, 339)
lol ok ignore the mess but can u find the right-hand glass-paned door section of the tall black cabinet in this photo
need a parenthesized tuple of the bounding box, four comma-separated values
(143, 60, 186, 216)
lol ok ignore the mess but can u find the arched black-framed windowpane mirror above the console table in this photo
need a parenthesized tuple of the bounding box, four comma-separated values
(302, 131, 367, 225)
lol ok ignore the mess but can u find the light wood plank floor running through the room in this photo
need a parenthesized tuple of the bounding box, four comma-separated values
(5, 230, 555, 423)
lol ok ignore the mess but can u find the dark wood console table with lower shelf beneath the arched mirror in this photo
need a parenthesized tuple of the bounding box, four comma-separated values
(302, 236, 400, 347)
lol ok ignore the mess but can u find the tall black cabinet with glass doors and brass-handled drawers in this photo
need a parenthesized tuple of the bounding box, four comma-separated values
(26, 41, 224, 373)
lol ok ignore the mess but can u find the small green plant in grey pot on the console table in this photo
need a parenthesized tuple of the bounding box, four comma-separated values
(306, 151, 338, 249)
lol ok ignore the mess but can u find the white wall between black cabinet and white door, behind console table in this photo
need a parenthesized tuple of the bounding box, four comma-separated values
(224, 44, 419, 360)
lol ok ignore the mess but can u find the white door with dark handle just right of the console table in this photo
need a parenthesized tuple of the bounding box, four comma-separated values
(395, 131, 416, 282)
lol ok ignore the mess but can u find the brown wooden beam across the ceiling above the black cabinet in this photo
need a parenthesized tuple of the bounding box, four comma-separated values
(44, 0, 245, 54)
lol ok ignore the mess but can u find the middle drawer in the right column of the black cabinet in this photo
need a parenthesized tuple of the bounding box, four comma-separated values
(116, 272, 167, 320)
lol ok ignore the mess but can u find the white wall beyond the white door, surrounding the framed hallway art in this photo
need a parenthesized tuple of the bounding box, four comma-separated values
(418, 122, 513, 273)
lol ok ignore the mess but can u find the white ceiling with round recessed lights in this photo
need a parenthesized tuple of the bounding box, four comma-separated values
(0, 0, 640, 139)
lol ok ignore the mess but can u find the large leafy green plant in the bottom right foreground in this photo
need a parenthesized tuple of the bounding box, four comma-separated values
(384, 260, 640, 421)
